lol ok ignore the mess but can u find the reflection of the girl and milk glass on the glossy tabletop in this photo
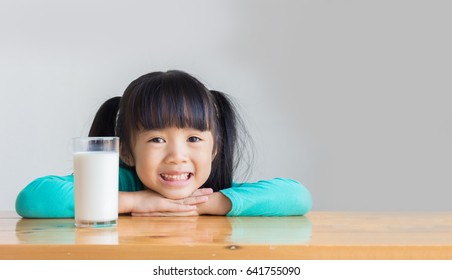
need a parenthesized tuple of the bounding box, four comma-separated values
(15, 216, 312, 244)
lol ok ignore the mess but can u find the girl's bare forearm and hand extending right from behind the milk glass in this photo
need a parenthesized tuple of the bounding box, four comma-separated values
(119, 189, 213, 216)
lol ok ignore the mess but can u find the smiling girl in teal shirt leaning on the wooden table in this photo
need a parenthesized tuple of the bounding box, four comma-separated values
(16, 71, 311, 218)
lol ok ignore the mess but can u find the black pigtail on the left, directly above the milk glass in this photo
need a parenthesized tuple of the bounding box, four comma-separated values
(88, 96, 121, 137)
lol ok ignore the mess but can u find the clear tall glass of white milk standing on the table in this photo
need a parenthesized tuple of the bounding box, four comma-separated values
(73, 137, 119, 228)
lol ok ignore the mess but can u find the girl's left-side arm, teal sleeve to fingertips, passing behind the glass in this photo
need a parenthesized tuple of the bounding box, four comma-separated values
(16, 175, 212, 218)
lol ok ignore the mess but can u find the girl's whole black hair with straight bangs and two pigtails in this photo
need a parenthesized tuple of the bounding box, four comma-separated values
(89, 70, 249, 191)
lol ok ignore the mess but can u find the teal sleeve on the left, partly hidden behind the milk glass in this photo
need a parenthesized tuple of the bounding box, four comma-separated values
(16, 168, 142, 218)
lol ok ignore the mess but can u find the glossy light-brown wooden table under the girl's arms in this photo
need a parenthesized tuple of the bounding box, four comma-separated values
(0, 212, 452, 260)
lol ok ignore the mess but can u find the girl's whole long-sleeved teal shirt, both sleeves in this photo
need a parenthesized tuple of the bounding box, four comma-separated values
(16, 168, 312, 218)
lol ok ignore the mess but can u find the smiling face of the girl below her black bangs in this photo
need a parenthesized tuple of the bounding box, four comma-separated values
(133, 127, 214, 199)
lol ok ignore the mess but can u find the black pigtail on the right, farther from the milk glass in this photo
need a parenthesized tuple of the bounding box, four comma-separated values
(206, 90, 252, 191)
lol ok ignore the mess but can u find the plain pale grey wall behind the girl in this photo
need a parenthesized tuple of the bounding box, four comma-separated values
(0, 0, 452, 211)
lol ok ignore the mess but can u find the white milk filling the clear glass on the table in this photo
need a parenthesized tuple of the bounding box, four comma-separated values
(74, 152, 119, 224)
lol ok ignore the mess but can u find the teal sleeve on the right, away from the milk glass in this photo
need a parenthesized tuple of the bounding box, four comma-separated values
(221, 178, 312, 216)
